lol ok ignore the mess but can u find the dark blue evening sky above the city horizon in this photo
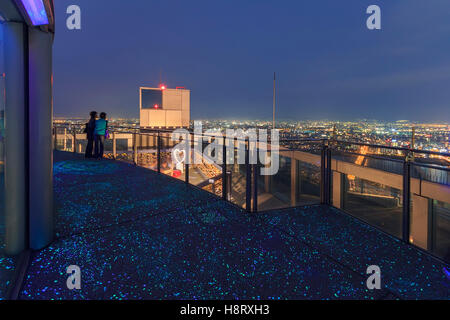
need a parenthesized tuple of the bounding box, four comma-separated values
(54, 0, 450, 121)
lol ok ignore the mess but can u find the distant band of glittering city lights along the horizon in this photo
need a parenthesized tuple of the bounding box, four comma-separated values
(55, 117, 450, 153)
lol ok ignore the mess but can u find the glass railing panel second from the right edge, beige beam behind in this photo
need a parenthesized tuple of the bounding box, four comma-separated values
(330, 148, 409, 238)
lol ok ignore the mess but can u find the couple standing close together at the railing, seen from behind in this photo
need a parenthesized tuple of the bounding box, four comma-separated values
(84, 111, 109, 159)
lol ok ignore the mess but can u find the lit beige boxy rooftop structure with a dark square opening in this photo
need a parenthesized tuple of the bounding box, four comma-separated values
(139, 86, 191, 128)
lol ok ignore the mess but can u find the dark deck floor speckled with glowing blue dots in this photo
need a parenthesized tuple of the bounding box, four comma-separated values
(21, 153, 450, 299)
